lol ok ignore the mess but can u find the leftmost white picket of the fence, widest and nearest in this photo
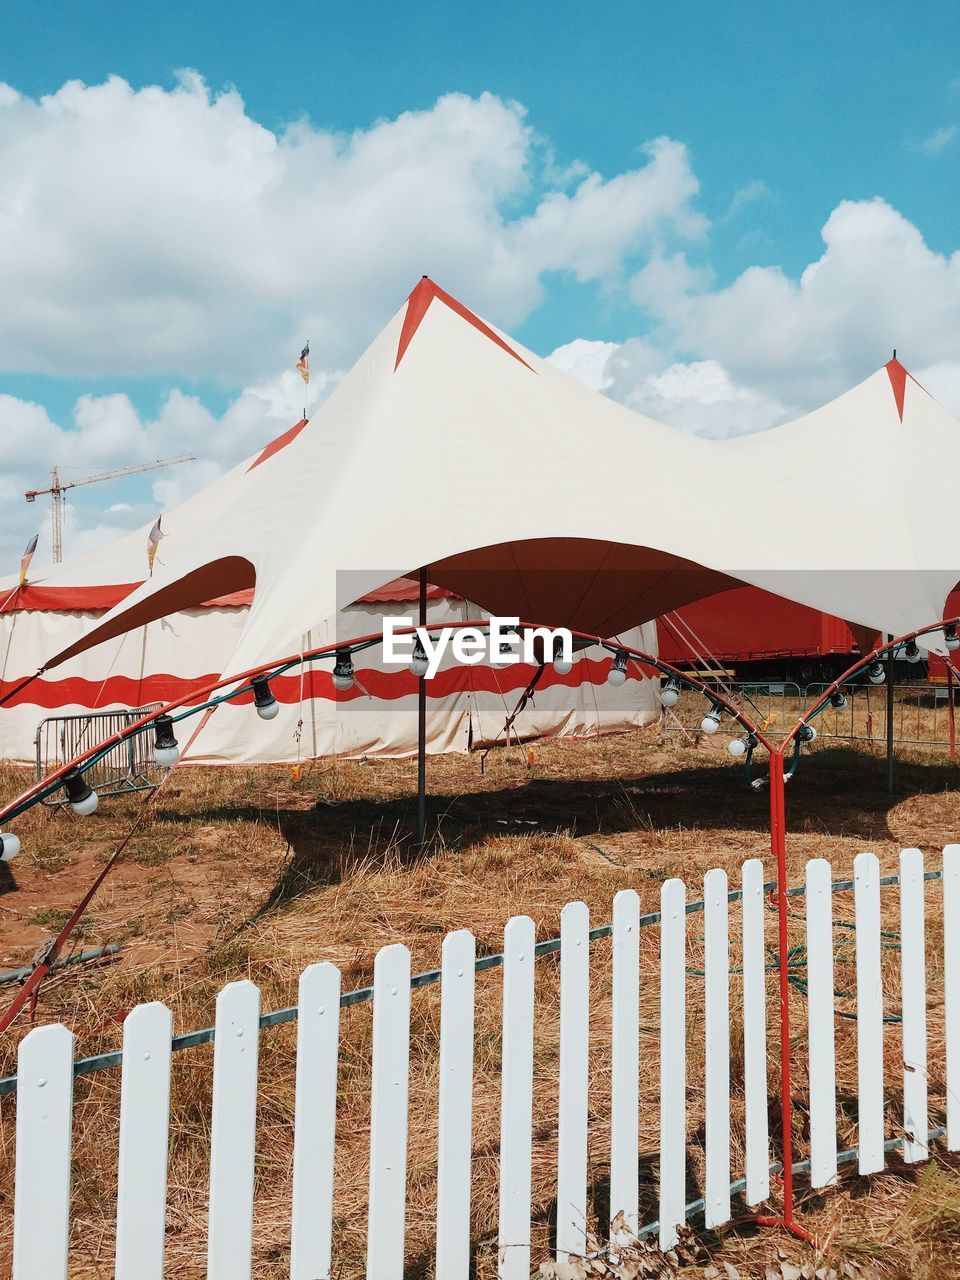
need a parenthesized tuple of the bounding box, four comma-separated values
(13, 1024, 73, 1280)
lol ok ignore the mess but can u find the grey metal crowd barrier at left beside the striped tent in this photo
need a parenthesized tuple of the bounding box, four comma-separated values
(35, 703, 163, 805)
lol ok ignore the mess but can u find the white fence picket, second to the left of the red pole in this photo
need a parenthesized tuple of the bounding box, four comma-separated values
(703, 870, 730, 1229)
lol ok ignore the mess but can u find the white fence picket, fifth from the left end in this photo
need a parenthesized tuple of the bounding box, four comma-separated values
(366, 943, 410, 1280)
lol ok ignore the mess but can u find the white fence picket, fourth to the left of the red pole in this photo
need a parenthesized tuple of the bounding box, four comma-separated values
(611, 888, 640, 1239)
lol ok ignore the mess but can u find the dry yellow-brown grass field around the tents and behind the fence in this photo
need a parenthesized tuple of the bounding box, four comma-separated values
(0, 730, 960, 1280)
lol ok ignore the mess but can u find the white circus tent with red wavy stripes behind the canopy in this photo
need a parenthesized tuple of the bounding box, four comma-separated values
(0, 412, 658, 764)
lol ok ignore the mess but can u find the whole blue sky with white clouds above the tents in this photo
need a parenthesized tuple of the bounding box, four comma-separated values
(0, 0, 960, 558)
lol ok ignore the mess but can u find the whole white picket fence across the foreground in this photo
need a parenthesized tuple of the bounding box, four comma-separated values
(13, 845, 960, 1280)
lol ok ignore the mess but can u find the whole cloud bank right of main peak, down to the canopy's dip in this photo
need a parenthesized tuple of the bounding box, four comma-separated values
(550, 200, 960, 435)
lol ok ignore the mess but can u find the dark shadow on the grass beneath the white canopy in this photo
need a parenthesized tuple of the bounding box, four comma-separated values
(165, 748, 960, 915)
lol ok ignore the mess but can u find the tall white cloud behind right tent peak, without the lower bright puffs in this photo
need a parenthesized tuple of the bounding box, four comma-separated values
(619, 200, 960, 407)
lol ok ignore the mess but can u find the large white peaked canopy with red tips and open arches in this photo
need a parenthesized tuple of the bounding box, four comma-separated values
(20, 278, 960, 672)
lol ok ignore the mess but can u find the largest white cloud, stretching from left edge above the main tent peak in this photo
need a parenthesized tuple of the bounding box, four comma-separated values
(0, 72, 705, 378)
